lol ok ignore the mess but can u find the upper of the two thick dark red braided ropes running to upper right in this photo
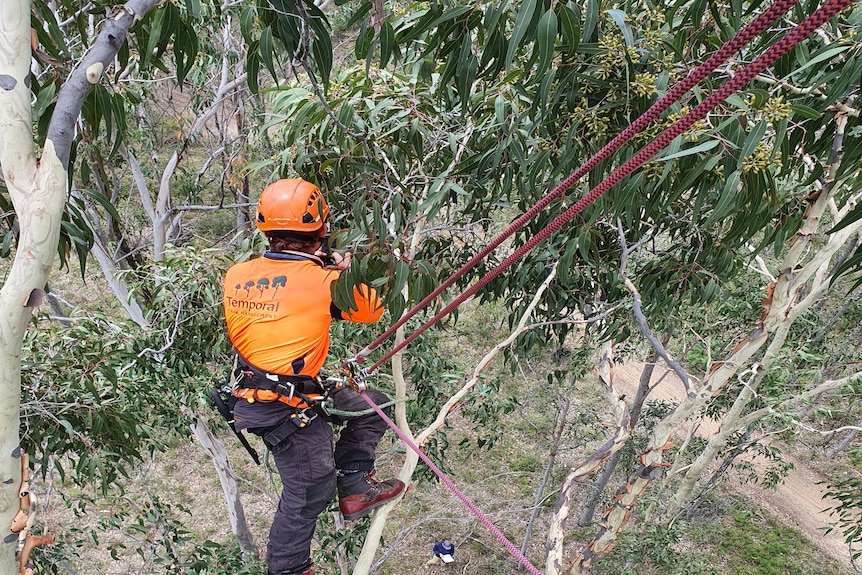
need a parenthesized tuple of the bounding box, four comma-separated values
(357, 0, 799, 364)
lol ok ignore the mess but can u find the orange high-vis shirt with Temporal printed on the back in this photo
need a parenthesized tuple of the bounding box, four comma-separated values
(224, 252, 383, 376)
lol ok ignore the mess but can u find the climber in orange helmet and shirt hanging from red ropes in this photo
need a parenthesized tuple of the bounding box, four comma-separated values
(224, 179, 404, 575)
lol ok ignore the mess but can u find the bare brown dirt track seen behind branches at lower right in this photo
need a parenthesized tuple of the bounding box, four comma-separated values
(614, 362, 853, 572)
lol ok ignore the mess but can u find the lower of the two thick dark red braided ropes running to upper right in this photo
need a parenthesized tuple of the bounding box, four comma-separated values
(359, 0, 853, 373)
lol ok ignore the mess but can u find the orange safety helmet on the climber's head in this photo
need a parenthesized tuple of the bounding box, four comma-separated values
(255, 178, 329, 232)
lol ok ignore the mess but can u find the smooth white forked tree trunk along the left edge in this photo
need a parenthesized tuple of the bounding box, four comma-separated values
(0, 0, 158, 575)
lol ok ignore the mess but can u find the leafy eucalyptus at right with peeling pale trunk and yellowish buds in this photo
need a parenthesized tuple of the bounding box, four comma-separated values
(255, 2, 862, 573)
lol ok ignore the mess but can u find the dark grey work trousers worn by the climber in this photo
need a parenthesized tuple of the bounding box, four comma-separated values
(235, 388, 389, 574)
